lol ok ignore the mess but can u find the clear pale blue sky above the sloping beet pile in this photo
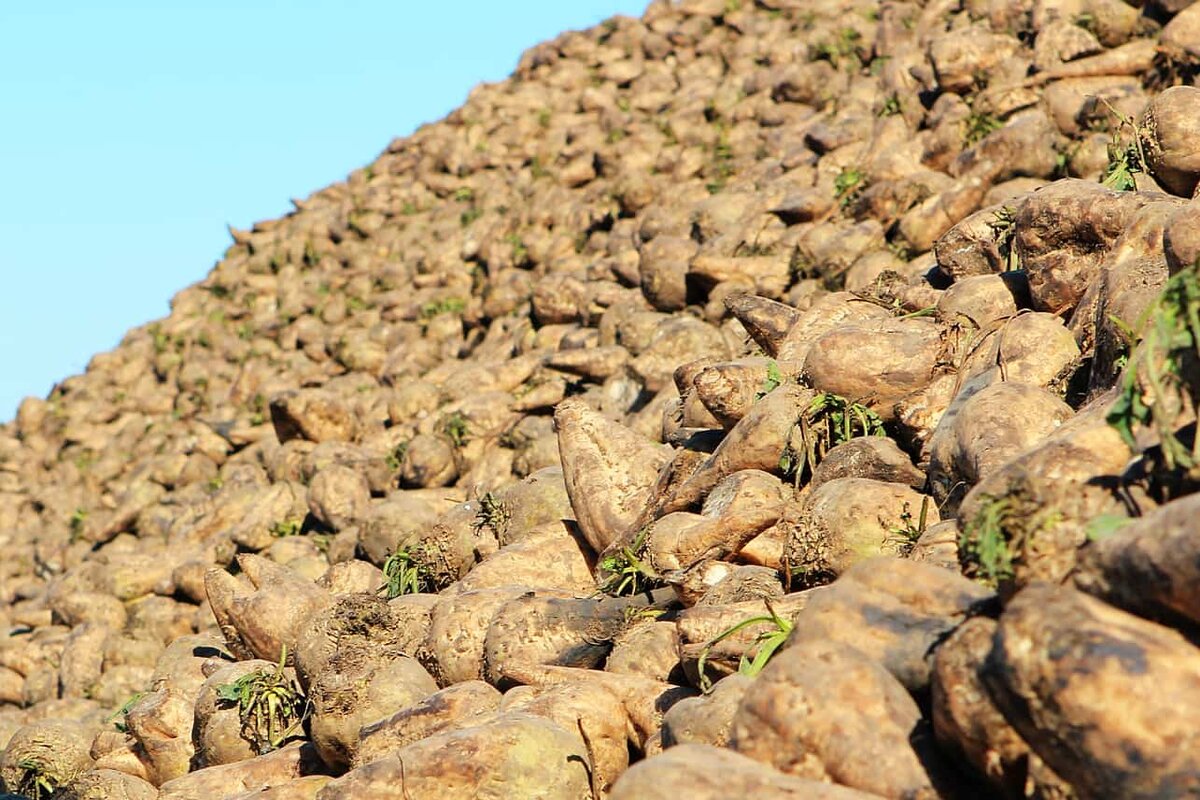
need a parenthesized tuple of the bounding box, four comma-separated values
(0, 0, 648, 421)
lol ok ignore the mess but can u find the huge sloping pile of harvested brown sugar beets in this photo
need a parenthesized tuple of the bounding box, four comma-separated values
(0, 0, 1200, 800)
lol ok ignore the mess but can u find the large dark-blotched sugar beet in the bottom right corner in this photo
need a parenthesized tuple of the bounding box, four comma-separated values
(984, 584, 1200, 798)
